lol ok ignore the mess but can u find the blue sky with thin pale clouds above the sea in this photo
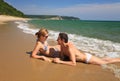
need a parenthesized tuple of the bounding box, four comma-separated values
(4, 0, 120, 21)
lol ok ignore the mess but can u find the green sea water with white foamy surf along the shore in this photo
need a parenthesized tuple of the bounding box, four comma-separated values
(15, 19, 120, 79)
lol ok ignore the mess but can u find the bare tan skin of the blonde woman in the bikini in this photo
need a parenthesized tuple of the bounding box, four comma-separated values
(32, 34, 60, 62)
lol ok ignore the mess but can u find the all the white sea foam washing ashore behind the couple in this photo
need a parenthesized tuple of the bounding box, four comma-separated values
(15, 21, 120, 78)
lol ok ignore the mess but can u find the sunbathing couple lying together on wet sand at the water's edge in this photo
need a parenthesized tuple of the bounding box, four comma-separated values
(32, 28, 120, 66)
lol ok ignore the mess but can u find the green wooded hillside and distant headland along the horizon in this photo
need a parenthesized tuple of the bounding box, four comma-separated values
(0, 0, 80, 20)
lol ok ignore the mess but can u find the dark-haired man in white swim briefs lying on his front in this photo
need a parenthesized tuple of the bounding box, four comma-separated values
(53, 33, 120, 66)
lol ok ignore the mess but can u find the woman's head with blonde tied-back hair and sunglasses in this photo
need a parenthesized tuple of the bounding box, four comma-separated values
(35, 28, 48, 41)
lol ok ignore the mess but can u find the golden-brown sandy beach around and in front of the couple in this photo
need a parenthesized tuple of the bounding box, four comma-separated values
(0, 17, 119, 81)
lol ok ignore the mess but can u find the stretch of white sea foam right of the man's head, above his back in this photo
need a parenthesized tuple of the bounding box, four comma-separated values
(69, 34, 120, 58)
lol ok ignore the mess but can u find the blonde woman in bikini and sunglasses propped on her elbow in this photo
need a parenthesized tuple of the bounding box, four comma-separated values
(32, 28, 60, 62)
